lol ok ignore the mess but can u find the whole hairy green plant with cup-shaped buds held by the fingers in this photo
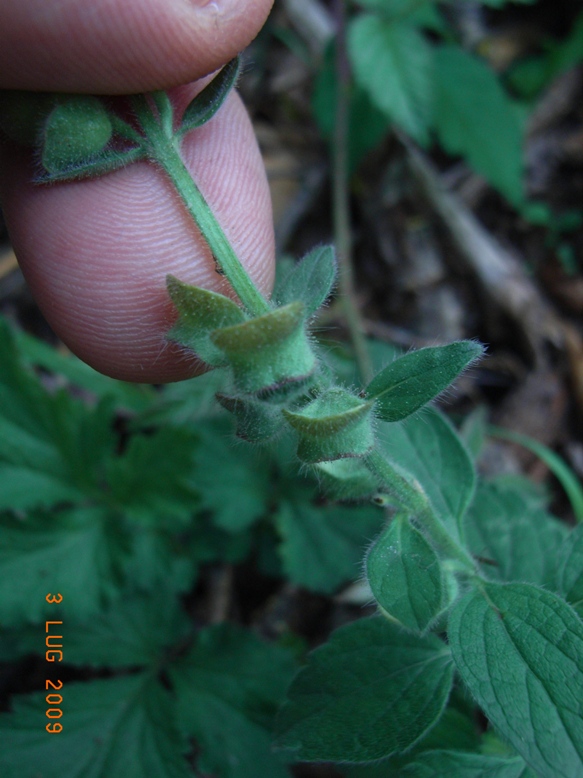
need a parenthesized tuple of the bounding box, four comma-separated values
(1, 59, 583, 778)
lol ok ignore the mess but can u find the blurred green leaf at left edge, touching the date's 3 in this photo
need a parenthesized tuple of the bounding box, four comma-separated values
(0, 508, 128, 625)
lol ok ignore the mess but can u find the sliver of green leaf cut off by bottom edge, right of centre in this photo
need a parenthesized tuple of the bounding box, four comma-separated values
(399, 751, 535, 778)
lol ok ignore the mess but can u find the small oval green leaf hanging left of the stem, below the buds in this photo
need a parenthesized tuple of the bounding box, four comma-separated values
(366, 514, 445, 633)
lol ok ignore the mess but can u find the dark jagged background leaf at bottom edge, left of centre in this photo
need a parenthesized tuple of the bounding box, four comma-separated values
(169, 624, 294, 778)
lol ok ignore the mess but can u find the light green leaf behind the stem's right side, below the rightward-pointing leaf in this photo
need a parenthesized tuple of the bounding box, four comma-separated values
(378, 408, 475, 538)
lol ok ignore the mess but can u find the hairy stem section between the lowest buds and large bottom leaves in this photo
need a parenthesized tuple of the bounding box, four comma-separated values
(363, 449, 476, 572)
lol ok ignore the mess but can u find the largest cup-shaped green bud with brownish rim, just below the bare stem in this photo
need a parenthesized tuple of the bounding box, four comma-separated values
(211, 302, 316, 401)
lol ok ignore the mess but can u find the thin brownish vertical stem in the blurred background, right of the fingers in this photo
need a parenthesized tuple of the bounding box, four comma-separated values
(332, 0, 372, 384)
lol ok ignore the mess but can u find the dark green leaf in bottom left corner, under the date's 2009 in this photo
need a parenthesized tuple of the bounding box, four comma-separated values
(0, 674, 192, 778)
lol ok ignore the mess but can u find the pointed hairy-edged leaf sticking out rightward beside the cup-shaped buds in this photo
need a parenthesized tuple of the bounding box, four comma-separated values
(366, 340, 484, 421)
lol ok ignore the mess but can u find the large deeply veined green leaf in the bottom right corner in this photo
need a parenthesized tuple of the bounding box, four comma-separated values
(448, 582, 583, 778)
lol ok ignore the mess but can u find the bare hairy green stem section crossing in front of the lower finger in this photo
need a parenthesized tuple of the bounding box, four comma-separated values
(134, 95, 271, 316)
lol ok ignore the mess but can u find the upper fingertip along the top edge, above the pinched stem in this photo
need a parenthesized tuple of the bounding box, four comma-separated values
(0, 0, 273, 94)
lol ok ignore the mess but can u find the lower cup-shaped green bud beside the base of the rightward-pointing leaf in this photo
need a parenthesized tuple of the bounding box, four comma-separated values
(283, 388, 374, 464)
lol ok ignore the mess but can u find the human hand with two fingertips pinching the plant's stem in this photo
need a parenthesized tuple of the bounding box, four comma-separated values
(0, 0, 274, 383)
